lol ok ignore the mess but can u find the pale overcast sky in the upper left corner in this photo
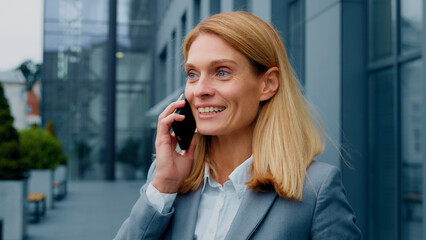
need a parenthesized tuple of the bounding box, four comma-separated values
(0, 0, 43, 71)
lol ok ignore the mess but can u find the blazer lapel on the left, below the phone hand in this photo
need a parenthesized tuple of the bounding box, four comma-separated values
(171, 188, 201, 239)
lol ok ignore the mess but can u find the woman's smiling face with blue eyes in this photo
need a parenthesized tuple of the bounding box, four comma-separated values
(185, 33, 262, 136)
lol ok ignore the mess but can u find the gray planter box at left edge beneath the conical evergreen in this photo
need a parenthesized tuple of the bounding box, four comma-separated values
(0, 179, 28, 240)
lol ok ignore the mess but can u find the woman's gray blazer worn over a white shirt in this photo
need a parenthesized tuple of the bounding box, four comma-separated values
(115, 161, 362, 240)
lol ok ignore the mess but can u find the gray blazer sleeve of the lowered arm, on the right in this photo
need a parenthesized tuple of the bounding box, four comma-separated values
(311, 167, 362, 240)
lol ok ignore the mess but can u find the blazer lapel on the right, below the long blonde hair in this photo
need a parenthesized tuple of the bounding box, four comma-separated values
(225, 189, 278, 240)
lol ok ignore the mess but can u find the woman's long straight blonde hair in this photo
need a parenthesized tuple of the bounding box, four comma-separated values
(179, 11, 324, 201)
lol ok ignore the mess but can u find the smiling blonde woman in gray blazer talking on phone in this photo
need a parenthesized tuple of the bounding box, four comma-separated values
(116, 12, 361, 240)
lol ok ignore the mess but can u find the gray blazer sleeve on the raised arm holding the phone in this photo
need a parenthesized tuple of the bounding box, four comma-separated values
(114, 161, 174, 240)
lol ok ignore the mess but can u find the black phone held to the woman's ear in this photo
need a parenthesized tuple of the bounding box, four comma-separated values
(172, 99, 196, 150)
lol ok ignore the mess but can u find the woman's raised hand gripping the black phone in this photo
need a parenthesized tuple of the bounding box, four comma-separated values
(151, 97, 195, 193)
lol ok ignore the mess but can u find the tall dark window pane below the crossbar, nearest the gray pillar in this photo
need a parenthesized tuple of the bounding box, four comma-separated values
(369, 69, 397, 239)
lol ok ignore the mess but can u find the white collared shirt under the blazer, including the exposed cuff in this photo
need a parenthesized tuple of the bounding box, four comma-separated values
(146, 156, 253, 240)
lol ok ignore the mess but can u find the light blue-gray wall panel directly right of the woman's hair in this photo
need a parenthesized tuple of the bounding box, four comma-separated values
(305, 0, 341, 167)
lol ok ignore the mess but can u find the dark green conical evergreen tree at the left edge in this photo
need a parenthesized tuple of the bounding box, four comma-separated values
(0, 83, 29, 179)
